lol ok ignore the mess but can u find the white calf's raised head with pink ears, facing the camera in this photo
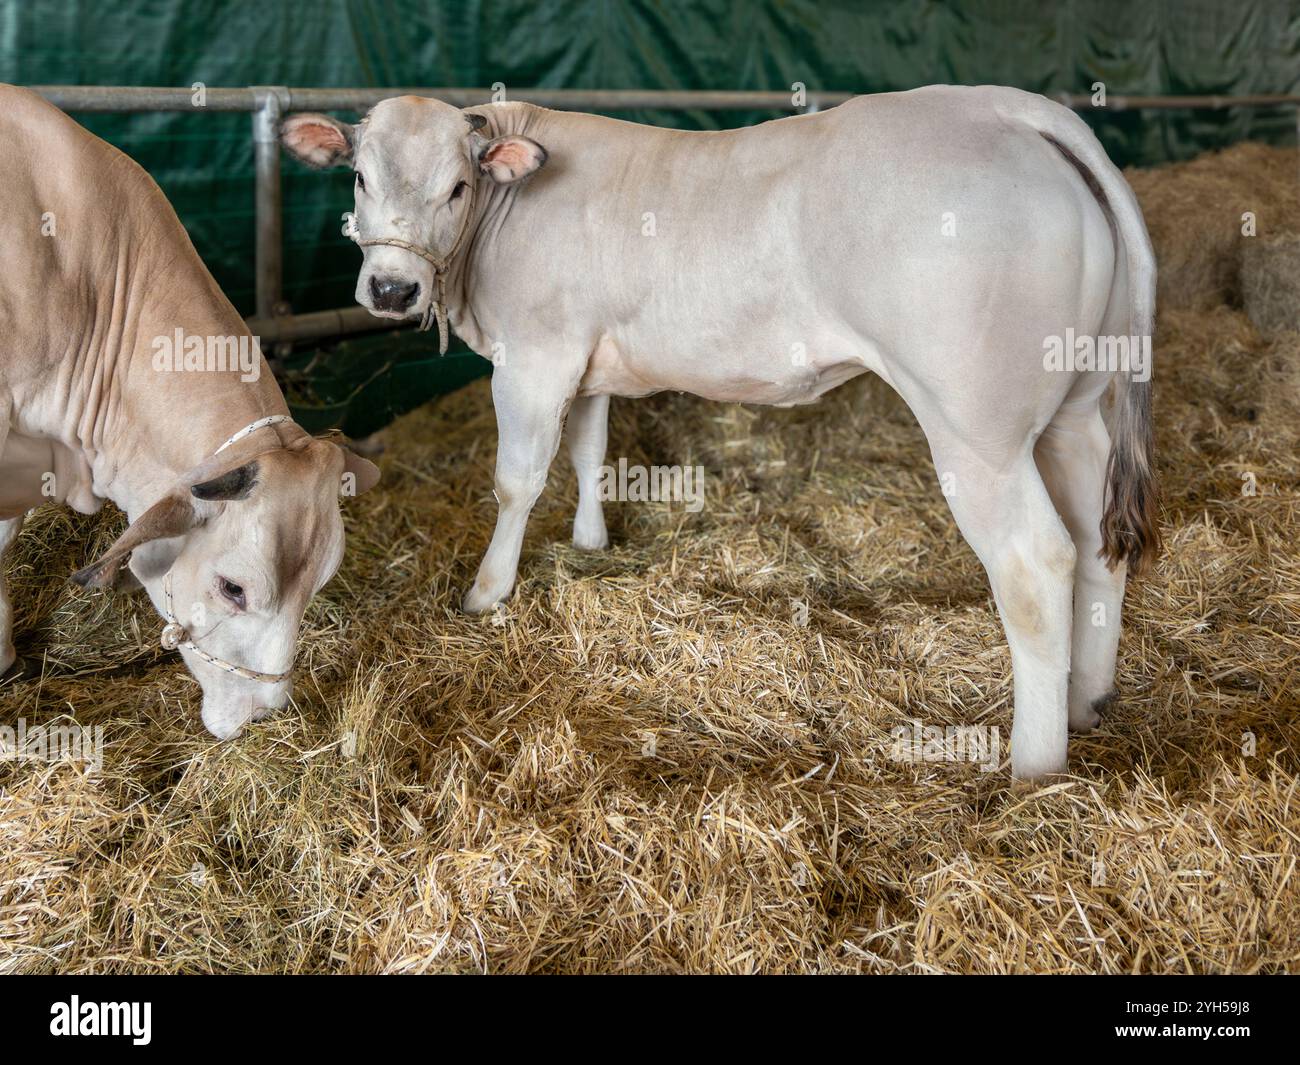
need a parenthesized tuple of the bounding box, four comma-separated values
(281, 96, 546, 325)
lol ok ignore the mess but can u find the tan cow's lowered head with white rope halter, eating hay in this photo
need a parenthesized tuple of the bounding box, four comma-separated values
(74, 425, 380, 739)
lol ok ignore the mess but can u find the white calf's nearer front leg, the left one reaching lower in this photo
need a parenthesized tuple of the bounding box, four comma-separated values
(463, 363, 577, 614)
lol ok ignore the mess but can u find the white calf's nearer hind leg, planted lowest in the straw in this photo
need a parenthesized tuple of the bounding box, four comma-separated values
(935, 442, 1075, 779)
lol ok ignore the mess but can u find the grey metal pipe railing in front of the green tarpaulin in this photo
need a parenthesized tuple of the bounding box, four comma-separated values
(31, 85, 1300, 343)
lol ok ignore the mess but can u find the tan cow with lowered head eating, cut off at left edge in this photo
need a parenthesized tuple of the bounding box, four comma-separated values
(0, 86, 378, 737)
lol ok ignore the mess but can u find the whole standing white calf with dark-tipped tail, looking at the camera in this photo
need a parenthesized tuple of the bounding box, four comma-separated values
(283, 87, 1157, 776)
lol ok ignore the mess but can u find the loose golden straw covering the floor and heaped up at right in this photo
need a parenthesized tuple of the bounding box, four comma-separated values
(0, 146, 1300, 973)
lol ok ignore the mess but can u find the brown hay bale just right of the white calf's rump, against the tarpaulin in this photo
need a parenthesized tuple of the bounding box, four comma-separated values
(1125, 143, 1300, 311)
